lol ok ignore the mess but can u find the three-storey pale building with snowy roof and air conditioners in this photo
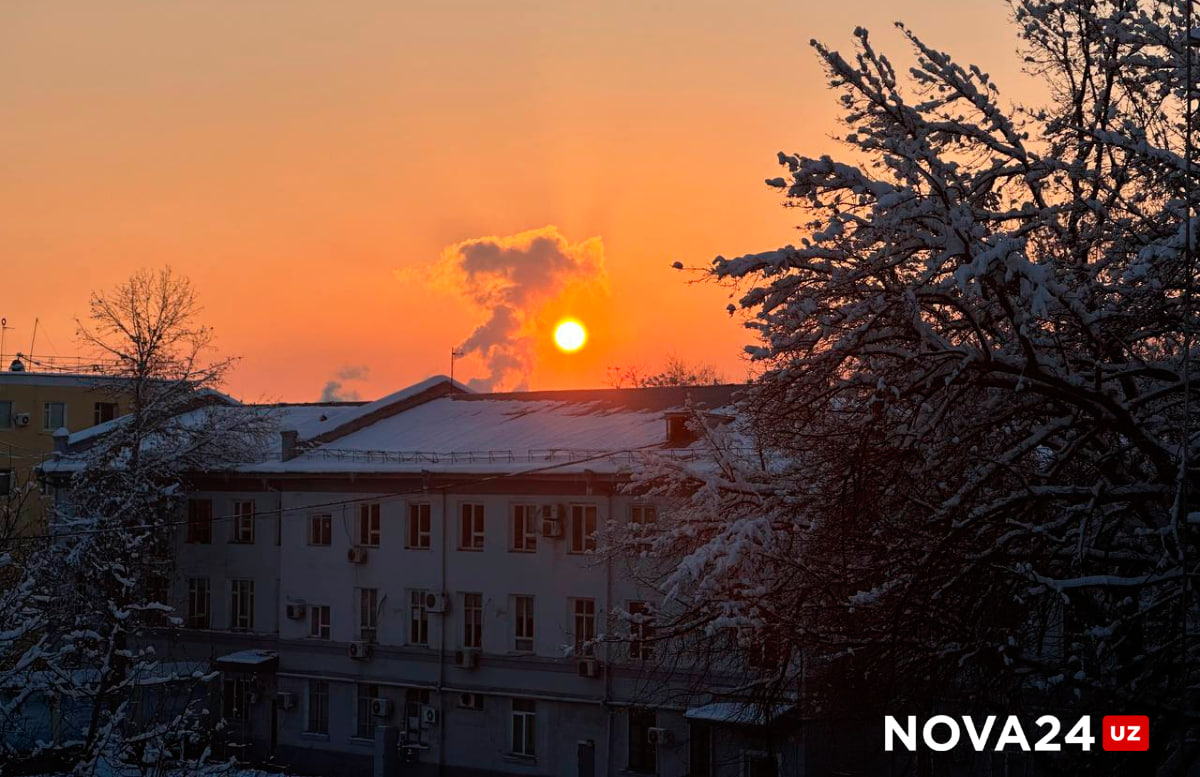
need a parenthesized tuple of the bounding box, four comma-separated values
(46, 378, 803, 777)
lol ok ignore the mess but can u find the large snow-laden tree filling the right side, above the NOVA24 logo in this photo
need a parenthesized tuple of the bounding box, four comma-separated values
(624, 0, 1200, 773)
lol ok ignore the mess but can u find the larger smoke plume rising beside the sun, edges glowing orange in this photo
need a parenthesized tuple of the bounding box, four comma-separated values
(440, 227, 606, 391)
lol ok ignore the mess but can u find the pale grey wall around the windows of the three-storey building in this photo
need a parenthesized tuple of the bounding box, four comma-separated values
(164, 480, 782, 776)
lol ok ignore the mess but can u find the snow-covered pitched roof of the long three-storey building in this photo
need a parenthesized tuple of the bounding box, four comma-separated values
(43, 375, 739, 475)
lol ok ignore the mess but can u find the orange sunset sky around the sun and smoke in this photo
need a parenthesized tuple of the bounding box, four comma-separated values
(0, 0, 1034, 400)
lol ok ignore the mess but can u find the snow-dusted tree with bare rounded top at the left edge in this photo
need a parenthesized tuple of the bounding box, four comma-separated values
(0, 269, 271, 775)
